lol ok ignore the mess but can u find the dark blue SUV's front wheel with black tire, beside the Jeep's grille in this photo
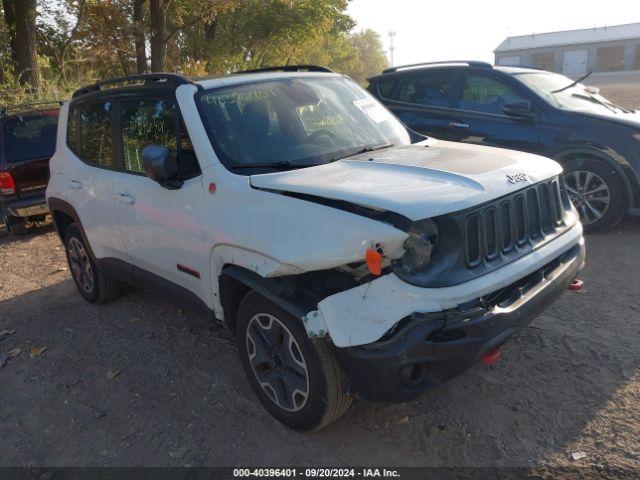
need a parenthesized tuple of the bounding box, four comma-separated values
(564, 157, 629, 233)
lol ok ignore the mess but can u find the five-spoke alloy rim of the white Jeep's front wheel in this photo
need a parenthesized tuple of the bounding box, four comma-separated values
(246, 313, 309, 412)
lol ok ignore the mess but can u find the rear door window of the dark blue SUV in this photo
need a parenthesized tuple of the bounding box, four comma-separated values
(393, 70, 455, 108)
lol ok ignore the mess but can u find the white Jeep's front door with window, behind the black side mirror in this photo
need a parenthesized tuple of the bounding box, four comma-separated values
(114, 98, 210, 301)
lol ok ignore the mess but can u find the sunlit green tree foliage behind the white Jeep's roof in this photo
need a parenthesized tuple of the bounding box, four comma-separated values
(0, 0, 387, 103)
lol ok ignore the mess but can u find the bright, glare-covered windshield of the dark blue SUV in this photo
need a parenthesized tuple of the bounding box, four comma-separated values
(511, 72, 625, 114)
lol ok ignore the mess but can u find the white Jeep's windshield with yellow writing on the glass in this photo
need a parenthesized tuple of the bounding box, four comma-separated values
(198, 76, 411, 173)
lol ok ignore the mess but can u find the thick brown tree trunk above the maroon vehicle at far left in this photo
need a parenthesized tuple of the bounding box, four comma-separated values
(15, 0, 40, 92)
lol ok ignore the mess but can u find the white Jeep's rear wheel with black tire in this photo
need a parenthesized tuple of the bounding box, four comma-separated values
(64, 223, 122, 303)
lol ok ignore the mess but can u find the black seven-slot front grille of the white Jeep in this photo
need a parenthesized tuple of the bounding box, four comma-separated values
(464, 178, 571, 268)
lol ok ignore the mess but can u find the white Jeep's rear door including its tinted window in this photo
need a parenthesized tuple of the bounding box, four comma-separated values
(61, 101, 128, 261)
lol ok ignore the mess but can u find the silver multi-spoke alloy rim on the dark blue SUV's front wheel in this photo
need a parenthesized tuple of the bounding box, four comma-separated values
(564, 170, 611, 225)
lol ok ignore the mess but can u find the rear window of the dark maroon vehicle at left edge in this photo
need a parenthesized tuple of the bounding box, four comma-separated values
(4, 111, 58, 162)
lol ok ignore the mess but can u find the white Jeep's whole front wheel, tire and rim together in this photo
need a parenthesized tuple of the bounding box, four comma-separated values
(236, 292, 352, 431)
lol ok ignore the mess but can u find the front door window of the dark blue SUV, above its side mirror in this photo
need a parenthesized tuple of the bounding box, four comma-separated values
(458, 73, 526, 115)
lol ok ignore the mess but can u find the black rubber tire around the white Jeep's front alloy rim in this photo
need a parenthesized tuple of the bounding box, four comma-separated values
(236, 291, 352, 431)
